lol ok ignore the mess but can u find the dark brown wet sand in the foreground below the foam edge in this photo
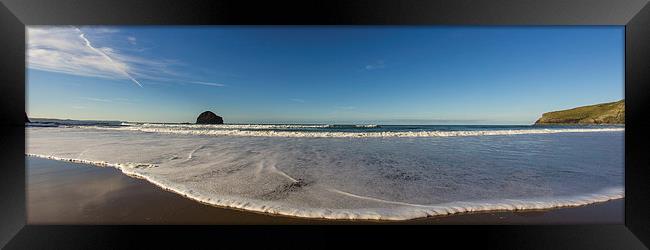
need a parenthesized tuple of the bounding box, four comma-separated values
(26, 157, 624, 225)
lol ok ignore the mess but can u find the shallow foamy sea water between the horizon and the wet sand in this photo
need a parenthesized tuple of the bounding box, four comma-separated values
(26, 123, 624, 220)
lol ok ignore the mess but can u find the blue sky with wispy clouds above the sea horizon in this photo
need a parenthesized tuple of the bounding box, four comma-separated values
(26, 26, 624, 124)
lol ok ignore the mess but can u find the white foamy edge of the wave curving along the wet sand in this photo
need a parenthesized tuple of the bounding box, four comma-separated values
(27, 154, 624, 220)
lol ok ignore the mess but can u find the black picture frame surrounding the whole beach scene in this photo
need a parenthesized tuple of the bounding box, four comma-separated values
(0, 0, 650, 249)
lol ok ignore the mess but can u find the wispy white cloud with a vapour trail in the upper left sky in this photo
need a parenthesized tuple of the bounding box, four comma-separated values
(27, 26, 225, 87)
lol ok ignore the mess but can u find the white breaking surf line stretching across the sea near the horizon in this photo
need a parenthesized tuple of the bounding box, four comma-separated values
(71, 124, 625, 138)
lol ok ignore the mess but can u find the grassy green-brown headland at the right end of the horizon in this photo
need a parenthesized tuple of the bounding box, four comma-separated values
(535, 100, 625, 124)
